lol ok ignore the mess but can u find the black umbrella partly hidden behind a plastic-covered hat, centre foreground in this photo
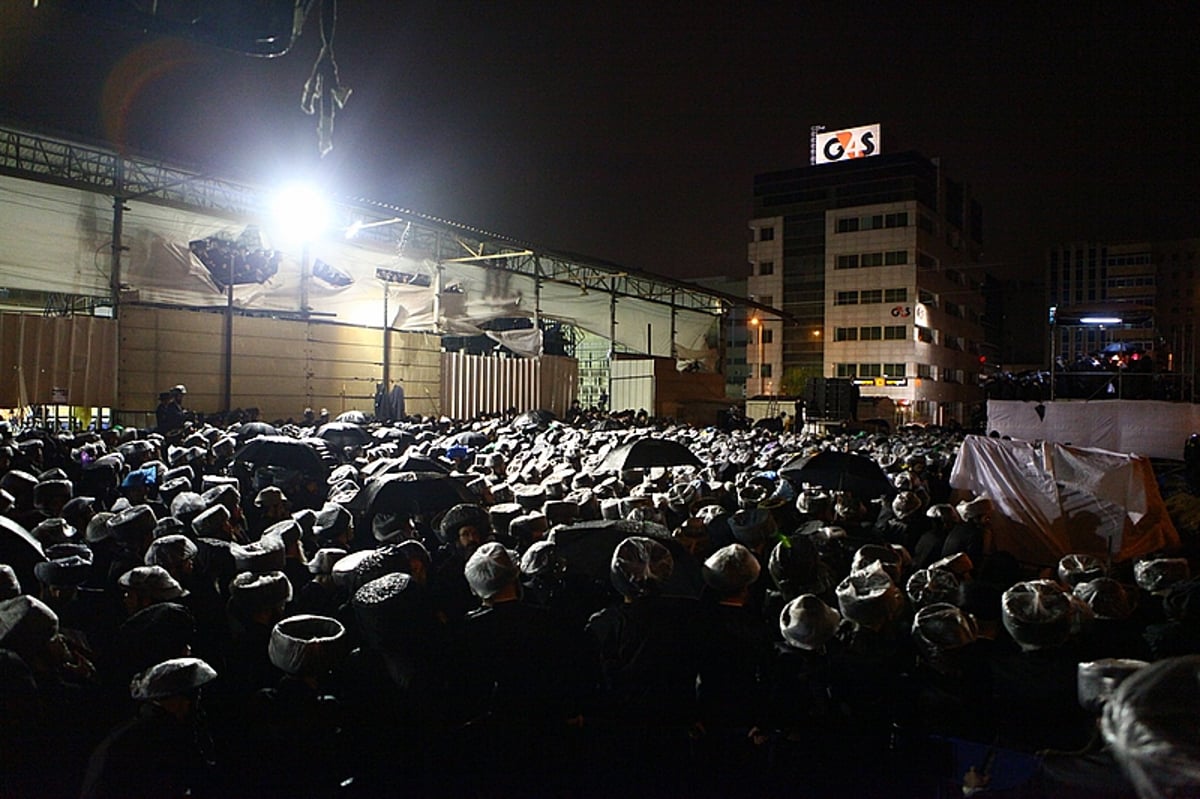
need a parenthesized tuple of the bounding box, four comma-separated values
(554, 519, 704, 597)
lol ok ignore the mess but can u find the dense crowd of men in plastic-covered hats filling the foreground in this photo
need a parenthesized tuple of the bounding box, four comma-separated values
(0, 407, 1200, 799)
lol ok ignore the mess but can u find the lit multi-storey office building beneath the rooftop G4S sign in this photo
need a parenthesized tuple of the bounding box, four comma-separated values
(746, 148, 986, 423)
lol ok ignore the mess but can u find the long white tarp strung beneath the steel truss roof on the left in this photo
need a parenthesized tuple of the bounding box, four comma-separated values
(0, 176, 713, 356)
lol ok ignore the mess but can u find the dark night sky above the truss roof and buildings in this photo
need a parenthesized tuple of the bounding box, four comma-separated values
(0, 0, 1200, 277)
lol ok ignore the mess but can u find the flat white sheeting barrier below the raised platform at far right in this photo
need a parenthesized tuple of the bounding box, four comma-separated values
(988, 400, 1200, 461)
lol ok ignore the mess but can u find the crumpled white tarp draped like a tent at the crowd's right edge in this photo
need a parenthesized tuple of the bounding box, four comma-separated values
(950, 435, 1180, 565)
